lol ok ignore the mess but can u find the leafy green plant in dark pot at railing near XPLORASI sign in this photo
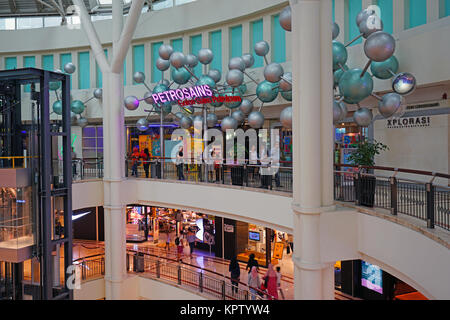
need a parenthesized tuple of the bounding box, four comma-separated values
(348, 139, 389, 207)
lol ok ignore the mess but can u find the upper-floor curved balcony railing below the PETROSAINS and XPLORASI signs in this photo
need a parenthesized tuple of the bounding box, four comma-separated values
(126, 157, 450, 230)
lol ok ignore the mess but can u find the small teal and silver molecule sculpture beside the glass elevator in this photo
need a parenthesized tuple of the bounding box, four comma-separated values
(49, 62, 103, 128)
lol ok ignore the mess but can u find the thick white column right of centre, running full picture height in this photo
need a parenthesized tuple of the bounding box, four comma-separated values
(291, 0, 334, 300)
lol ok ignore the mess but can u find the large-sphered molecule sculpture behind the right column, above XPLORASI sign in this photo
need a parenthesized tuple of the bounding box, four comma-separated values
(279, 6, 416, 127)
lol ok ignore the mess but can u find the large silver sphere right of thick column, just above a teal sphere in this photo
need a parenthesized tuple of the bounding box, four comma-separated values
(364, 31, 395, 62)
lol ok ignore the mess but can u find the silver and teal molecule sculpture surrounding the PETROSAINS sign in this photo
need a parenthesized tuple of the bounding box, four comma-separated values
(124, 36, 292, 132)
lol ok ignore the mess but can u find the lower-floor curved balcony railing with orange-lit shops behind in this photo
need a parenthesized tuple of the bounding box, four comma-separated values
(74, 250, 273, 300)
